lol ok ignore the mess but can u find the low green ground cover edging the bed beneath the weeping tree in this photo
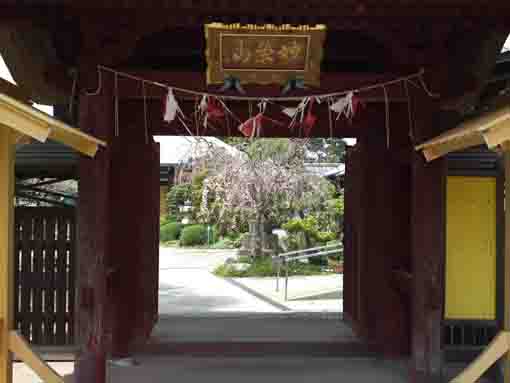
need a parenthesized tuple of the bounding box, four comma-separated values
(214, 257, 330, 278)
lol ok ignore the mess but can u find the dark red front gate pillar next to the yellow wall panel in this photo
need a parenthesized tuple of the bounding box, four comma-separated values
(411, 95, 447, 382)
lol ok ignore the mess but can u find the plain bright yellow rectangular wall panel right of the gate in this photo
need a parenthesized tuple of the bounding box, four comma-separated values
(445, 176, 496, 319)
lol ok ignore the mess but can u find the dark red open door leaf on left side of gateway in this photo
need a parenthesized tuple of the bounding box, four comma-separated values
(108, 130, 159, 358)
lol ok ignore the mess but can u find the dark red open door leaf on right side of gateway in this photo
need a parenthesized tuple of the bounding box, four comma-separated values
(344, 118, 410, 356)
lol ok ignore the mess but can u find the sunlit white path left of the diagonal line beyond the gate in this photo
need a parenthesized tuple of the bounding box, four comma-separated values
(159, 248, 282, 317)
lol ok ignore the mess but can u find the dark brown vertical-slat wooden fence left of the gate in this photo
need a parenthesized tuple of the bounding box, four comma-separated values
(15, 207, 76, 346)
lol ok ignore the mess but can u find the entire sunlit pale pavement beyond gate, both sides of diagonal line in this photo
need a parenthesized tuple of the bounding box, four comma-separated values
(159, 247, 343, 316)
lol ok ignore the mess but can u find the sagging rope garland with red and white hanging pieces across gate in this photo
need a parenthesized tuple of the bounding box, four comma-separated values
(86, 66, 438, 142)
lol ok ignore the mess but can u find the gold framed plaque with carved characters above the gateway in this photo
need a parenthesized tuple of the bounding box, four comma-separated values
(205, 23, 326, 86)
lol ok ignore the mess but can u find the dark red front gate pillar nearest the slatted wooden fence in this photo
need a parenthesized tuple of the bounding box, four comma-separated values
(75, 70, 114, 383)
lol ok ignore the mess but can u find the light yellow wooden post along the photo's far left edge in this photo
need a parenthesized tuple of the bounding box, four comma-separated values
(0, 129, 15, 383)
